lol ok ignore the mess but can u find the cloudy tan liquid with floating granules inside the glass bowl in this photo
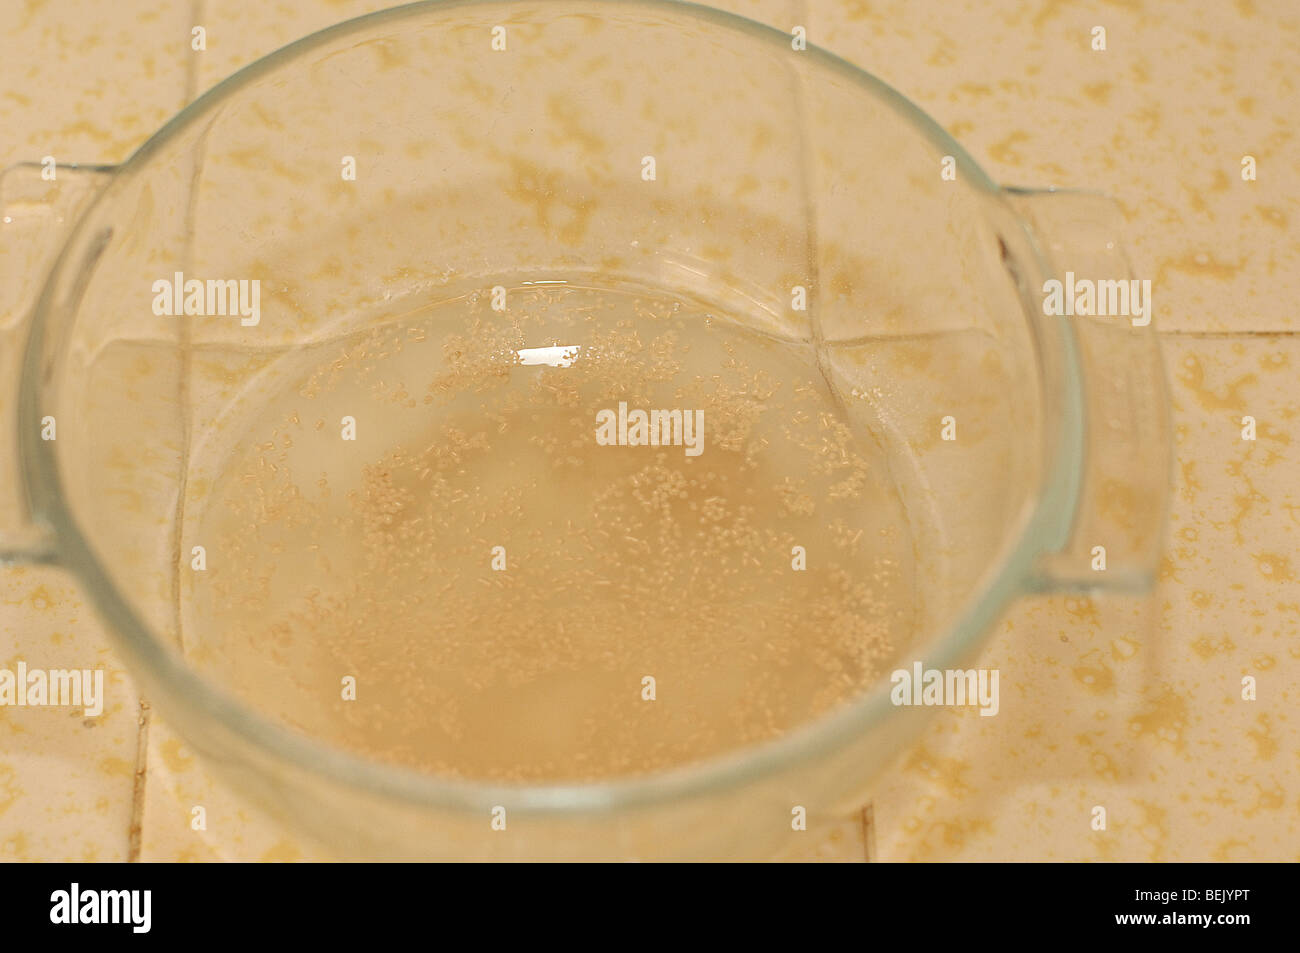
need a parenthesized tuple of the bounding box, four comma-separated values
(182, 285, 911, 781)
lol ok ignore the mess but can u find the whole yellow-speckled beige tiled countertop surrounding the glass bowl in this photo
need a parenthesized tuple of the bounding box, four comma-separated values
(0, 0, 1300, 861)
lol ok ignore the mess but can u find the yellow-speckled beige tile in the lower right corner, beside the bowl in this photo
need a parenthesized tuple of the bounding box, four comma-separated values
(874, 337, 1300, 861)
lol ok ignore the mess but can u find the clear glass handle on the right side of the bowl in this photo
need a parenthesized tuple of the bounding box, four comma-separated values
(1006, 190, 1173, 593)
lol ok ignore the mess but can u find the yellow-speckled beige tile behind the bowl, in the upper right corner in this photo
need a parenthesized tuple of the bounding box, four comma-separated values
(810, 0, 1300, 330)
